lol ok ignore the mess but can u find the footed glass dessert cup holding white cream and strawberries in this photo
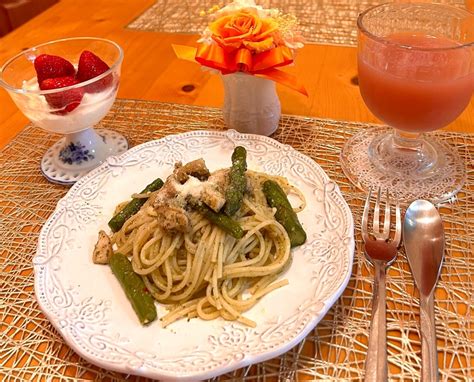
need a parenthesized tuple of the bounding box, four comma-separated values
(0, 37, 128, 184)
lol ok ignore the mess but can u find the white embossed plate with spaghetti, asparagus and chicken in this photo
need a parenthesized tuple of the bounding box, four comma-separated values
(34, 131, 354, 380)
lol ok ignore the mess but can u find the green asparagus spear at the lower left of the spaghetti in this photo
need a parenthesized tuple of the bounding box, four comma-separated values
(110, 253, 157, 325)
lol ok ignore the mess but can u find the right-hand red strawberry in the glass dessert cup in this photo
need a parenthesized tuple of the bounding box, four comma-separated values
(76, 50, 113, 93)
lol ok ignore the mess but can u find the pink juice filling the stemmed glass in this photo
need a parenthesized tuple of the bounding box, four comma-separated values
(358, 33, 474, 132)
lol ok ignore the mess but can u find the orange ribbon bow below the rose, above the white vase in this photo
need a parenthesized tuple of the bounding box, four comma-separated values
(172, 44, 308, 96)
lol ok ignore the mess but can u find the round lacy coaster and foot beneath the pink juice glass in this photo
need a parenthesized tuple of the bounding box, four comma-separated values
(340, 127, 466, 203)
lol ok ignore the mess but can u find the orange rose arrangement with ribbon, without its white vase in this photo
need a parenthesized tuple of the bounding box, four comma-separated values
(173, 0, 307, 95)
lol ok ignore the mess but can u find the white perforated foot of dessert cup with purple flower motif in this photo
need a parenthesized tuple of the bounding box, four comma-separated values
(41, 128, 128, 185)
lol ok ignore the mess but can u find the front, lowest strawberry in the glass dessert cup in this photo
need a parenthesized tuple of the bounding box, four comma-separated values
(40, 76, 84, 114)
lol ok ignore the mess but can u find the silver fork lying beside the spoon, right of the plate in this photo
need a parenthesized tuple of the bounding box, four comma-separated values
(362, 188, 402, 382)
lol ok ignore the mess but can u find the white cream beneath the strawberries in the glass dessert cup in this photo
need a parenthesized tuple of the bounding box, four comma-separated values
(12, 78, 118, 134)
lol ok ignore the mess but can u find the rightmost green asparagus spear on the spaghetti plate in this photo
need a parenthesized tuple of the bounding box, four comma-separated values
(263, 180, 306, 248)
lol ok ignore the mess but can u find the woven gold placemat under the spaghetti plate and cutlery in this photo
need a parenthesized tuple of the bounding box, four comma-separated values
(0, 100, 474, 382)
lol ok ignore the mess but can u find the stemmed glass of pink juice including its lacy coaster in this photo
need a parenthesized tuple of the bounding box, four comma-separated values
(341, 3, 474, 203)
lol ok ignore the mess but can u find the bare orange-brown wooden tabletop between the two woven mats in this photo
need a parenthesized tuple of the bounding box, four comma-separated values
(0, 0, 474, 147)
